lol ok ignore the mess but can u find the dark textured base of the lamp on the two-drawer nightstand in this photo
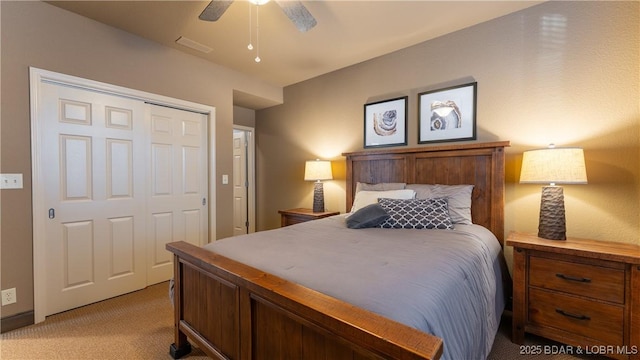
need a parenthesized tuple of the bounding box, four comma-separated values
(538, 186, 567, 240)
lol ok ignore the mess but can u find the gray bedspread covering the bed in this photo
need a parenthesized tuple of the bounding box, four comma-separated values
(205, 215, 504, 359)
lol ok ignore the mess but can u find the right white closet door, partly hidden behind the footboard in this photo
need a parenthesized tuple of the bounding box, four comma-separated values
(147, 105, 208, 284)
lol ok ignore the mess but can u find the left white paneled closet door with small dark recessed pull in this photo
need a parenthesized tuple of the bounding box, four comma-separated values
(40, 83, 146, 315)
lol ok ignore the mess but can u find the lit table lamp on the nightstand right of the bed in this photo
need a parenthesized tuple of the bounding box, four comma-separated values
(520, 144, 587, 240)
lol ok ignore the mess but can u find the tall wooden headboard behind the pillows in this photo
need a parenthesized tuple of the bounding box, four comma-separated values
(342, 141, 509, 243)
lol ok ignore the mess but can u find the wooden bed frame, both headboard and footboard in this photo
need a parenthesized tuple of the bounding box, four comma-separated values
(167, 141, 509, 359)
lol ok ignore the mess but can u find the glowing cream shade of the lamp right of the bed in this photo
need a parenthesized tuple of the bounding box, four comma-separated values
(520, 147, 587, 184)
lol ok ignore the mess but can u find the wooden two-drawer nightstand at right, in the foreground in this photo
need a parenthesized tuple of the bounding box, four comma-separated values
(506, 232, 640, 359)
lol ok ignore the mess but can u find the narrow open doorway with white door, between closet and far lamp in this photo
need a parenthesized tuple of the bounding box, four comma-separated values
(233, 125, 256, 236)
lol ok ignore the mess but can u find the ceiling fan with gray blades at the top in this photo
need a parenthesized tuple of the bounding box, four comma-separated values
(199, 0, 317, 32)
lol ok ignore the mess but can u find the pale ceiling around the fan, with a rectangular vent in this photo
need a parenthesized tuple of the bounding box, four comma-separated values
(49, 0, 542, 86)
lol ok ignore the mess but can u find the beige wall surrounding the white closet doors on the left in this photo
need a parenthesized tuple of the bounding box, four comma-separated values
(0, 1, 282, 318)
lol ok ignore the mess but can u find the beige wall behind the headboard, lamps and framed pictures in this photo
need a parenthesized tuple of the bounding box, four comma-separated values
(256, 2, 640, 260)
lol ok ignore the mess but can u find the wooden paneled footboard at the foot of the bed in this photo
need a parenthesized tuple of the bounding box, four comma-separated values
(167, 242, 442, 359)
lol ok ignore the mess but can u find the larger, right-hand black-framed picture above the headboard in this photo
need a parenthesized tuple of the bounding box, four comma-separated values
(418, 82, 478, 144)
